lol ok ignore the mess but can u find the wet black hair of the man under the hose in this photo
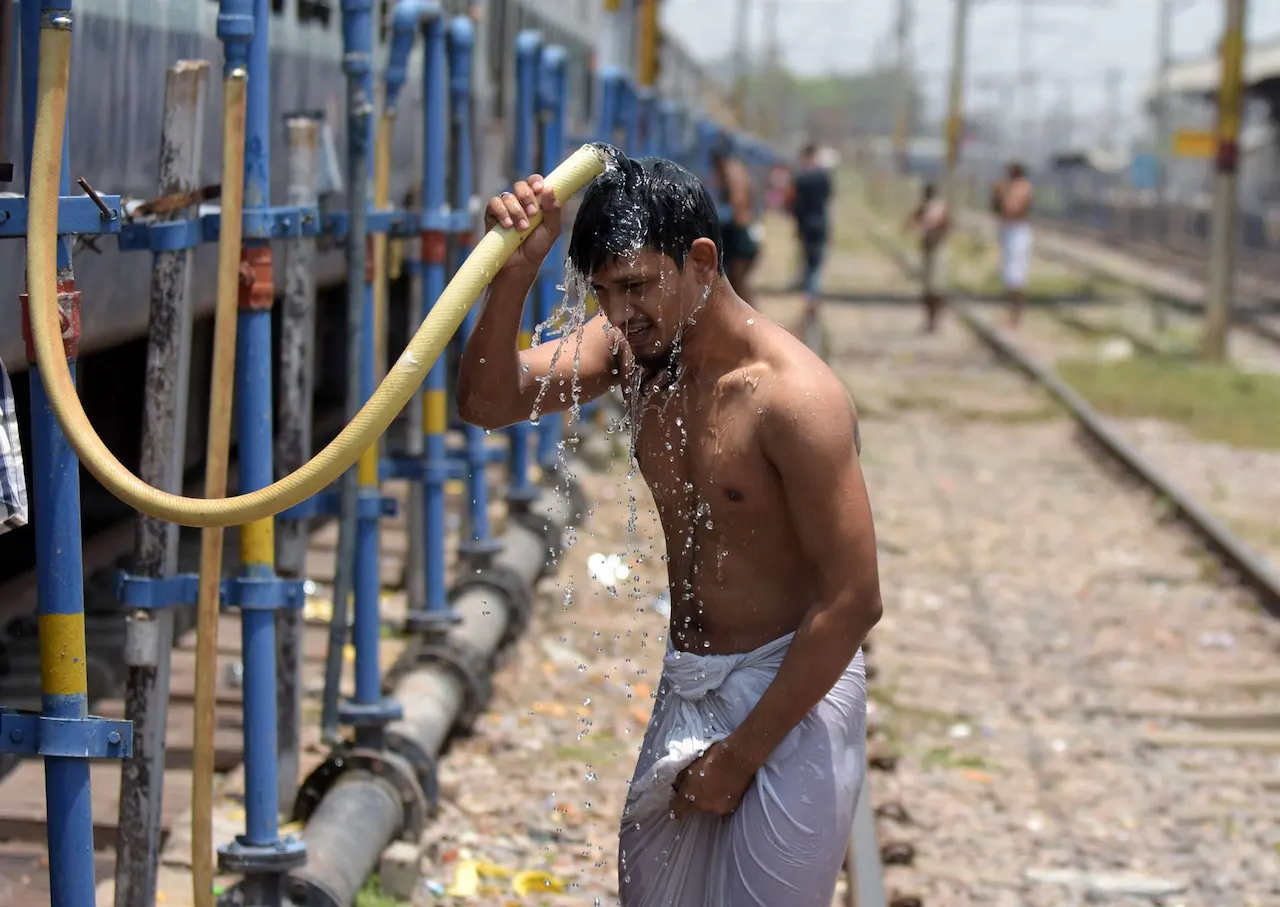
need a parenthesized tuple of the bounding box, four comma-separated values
(568, 155, 724, 275)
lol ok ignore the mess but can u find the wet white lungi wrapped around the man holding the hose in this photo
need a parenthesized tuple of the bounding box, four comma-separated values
(618, 633, 867, 907)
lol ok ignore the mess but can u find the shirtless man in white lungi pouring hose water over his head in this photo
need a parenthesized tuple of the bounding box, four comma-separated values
(458, 159, 881, 907)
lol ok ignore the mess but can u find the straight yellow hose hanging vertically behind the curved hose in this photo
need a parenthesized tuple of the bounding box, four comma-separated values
(191, 69, 248, 907)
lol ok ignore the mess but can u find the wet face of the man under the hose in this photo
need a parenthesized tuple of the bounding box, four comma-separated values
(591, 248, 716, 362)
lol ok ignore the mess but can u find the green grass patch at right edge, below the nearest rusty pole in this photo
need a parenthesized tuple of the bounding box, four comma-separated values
(1057, 356, 1280, 450)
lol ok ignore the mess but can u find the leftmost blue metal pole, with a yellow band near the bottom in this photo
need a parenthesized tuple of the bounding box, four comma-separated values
(19, 0, 93, 907)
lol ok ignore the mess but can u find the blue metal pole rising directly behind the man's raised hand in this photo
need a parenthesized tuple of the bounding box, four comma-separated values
(536, 45, 571, 473)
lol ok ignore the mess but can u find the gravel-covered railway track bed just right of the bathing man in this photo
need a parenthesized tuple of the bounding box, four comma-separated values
(788, 225, 1280, 907)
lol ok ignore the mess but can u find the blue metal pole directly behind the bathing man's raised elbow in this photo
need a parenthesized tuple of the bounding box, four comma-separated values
(447, 15, 502, 563)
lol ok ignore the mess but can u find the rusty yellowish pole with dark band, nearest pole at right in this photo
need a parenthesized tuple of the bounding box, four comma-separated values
(1204, 0, 1245, 362)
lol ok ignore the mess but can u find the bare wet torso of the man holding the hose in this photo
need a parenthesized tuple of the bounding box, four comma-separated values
(628, 306, 856, 654)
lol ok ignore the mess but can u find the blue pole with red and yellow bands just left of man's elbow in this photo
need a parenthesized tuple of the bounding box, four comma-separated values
(416, 17, 452, 619)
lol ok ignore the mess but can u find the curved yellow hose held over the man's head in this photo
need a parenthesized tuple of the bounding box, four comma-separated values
(27, 29, 605, 527)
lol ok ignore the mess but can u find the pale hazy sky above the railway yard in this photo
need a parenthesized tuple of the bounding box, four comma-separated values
(662, 0, 1280, 116)
